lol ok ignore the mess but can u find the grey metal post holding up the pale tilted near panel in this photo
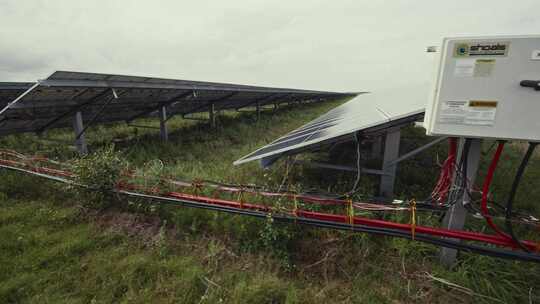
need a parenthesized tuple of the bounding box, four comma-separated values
(379, 129, 401, 199)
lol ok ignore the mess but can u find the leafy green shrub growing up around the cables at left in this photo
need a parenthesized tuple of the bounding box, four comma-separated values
(68, 146, 128, 209)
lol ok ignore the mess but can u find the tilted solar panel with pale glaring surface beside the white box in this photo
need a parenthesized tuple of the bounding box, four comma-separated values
(234, 89, 427, 165)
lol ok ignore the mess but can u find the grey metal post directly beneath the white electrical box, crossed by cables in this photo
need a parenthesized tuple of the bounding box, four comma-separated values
(439, 138, 482, 267)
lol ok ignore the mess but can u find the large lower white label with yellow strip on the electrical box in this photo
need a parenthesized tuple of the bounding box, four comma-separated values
(439, 100, 497, 126)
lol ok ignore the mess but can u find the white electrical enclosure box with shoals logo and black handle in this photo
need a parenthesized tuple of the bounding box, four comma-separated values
(424, 36, 540, 141)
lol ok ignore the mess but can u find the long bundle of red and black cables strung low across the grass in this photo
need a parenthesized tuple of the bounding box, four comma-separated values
(1, 159, 540, 262)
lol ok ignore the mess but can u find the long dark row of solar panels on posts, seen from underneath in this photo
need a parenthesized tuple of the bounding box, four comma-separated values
(0, 71, 355, 135)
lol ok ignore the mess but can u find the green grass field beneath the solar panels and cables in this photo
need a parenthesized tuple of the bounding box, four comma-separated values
(0, 101, 540, 304)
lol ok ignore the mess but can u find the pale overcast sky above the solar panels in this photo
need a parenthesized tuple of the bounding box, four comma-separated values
(0, 0, 540, 91)
